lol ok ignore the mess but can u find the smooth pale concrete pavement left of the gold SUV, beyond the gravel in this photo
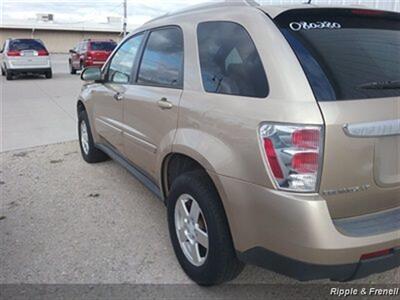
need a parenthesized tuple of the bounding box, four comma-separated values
(0, 54, 82, 151)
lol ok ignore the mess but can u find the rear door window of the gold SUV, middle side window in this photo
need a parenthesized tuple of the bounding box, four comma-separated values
(137, 27, 183, 88)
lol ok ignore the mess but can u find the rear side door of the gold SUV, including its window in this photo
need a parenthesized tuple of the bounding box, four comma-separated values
(123, 26, 183, 178)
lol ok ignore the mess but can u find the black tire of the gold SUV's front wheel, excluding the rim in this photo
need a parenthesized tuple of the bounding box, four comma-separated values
(78, 110, 108, 163)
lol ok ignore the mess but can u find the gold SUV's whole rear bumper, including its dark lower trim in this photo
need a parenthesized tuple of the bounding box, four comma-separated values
(210, 174, 400, 280)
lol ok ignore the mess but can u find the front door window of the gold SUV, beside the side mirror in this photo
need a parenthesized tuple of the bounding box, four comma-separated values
(108, 34, 143, 83)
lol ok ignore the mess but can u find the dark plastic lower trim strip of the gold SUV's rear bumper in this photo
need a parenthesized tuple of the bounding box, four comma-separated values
(238, 247, 400, 281)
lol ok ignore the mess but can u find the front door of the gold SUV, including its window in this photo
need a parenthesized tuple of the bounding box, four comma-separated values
(93, 34, 143, 153)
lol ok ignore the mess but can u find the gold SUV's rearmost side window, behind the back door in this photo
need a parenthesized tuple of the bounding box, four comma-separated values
(197, 21, 268, 98)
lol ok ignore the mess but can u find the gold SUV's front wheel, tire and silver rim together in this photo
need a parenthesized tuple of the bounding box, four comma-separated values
(78, 110, 108, 163)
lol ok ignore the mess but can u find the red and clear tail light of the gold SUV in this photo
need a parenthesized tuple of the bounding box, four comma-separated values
(260, 124, 323, 192)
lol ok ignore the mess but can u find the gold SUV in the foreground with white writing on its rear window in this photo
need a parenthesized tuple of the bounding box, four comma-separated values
(77, 2, 400, 285)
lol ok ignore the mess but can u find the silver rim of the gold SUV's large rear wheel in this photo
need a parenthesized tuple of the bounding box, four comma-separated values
(175, 194, 209, 266)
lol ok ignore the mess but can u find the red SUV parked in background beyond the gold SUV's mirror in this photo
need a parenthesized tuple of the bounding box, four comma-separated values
(69, 39, 117, 74)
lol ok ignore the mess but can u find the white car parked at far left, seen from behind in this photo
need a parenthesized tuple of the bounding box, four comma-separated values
(0, 39, 52, 80)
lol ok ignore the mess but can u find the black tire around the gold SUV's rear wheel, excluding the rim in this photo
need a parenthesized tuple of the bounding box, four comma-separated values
(167, 171, 244, 286)
